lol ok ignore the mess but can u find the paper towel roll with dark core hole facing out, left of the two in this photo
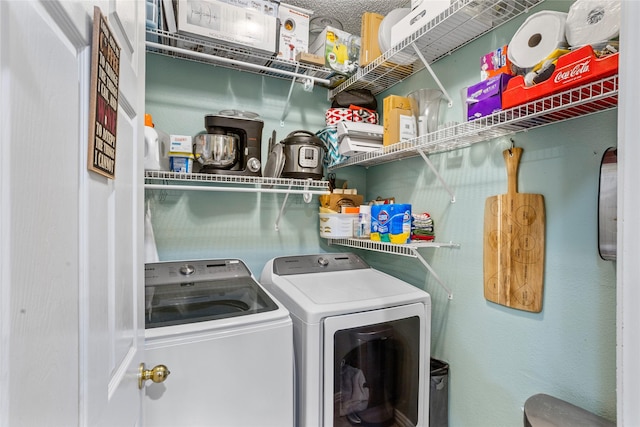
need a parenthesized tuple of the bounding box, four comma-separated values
(507, 10, 567, 72)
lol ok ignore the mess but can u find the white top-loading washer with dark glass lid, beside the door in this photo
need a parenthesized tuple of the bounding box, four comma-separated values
(144, 259, 294, 427)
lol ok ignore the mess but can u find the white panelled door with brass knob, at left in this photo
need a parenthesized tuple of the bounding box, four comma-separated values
(0, 0, 145, 426)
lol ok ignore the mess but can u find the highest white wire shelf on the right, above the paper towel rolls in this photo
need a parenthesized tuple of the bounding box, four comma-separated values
(329, 0, 544, 98)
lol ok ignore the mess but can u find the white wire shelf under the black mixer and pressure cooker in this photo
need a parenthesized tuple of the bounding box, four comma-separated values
(144, 171, 330, 195)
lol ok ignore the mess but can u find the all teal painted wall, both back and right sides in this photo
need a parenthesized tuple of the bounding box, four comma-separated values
(147, 1, 617, 427)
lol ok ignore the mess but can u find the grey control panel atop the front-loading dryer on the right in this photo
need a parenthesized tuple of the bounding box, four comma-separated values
(273, 253, 370, 276)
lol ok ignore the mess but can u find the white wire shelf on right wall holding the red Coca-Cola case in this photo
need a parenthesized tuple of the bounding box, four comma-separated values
(329, 75, 618, 170)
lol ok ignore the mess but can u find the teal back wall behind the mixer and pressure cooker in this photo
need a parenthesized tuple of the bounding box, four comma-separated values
(146, 54, 366, 276)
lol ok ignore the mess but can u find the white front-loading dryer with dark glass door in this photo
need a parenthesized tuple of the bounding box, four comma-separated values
(260, 253, 431, 427)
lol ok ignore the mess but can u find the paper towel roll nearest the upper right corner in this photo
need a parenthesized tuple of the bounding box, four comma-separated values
(566, 0, 621, 47)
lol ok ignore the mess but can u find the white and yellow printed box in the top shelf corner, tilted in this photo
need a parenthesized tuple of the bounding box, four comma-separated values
(309, 27, 360, 76)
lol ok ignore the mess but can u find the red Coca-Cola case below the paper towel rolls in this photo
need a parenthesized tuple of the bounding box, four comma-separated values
(502, 45, 619, 110)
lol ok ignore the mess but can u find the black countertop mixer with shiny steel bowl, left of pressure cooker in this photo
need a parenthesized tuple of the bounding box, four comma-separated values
(194, 110, 264, 176)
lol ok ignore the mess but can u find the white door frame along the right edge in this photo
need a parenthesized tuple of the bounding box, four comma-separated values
(616, 1, 640, 426)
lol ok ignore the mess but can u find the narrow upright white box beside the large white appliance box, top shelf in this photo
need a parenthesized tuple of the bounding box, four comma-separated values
(278, 3, 313, 61)
